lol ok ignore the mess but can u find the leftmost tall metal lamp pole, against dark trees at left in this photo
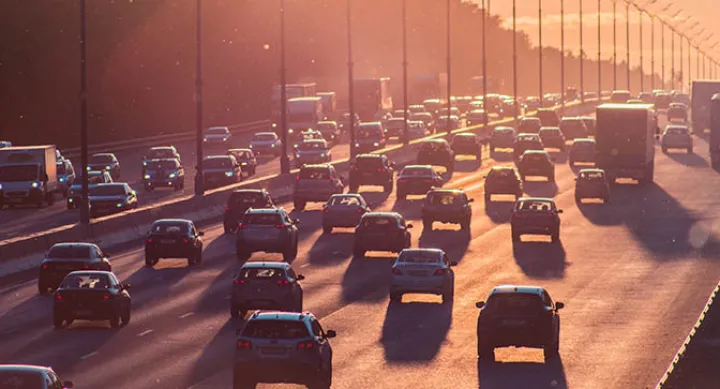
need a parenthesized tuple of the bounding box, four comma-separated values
(80, 0, 90, 224)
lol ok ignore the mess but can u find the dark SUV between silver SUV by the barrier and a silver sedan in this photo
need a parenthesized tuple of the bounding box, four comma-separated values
(349, 154, 395, 193)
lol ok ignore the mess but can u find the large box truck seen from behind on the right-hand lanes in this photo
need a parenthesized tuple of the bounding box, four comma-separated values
(595, 104, 659, 183)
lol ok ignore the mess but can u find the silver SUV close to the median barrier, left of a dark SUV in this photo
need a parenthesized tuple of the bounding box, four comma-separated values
(293, 164, 345, 211)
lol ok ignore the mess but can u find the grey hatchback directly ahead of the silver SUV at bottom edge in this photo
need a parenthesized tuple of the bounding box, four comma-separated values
(230, 261, 305, 318)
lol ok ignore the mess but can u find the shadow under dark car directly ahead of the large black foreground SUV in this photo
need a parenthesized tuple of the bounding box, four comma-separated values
(513, 238, 567, 279)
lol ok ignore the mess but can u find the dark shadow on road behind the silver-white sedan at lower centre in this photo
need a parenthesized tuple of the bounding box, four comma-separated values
(380, 296, 453, 363)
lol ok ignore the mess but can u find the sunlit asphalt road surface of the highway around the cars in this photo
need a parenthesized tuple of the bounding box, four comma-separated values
(0, 113, 720, 389)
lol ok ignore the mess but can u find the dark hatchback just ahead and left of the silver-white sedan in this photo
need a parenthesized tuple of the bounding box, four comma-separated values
(353, 212, 413, 258)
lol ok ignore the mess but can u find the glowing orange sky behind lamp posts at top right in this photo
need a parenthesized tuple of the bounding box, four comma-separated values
(473, 0, 720, 79)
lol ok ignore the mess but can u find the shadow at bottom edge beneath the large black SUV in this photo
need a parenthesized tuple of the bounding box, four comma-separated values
(477, 358, 568, 389)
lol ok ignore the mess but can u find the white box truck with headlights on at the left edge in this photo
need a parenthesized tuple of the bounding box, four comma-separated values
(0, 145, 60, 208)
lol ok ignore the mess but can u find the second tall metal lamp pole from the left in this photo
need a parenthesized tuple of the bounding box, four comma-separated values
(195, 0, 205, 196)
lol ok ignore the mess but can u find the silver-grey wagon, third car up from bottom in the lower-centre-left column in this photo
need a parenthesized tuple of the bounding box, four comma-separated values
(235, 208, 300, 262)
